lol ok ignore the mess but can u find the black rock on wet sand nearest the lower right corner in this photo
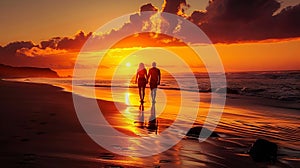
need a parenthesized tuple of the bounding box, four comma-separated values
(249, 139, 278, 162)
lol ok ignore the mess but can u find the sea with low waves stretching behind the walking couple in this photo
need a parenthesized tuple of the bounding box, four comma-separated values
(21, 70, 300, 103)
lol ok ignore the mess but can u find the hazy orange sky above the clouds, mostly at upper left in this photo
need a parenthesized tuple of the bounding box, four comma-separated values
(0, 0, 299, 46)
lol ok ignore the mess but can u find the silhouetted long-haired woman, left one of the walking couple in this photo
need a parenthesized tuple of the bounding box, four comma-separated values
(135, 63, 147, 103)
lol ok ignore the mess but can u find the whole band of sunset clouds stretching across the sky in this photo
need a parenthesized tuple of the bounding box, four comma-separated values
(0, 0, 300, 68)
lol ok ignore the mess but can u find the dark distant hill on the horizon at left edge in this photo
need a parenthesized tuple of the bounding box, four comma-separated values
(0, 64, 59, 78)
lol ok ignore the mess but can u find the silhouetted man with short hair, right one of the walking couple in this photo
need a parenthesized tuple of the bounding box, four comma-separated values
(147, 62, 161, 103)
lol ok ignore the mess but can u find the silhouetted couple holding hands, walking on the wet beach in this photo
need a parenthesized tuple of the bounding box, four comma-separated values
(135, 62, 160, 103)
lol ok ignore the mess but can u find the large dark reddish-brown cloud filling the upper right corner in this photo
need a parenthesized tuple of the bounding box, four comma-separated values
(190, 0, 300, 43)
